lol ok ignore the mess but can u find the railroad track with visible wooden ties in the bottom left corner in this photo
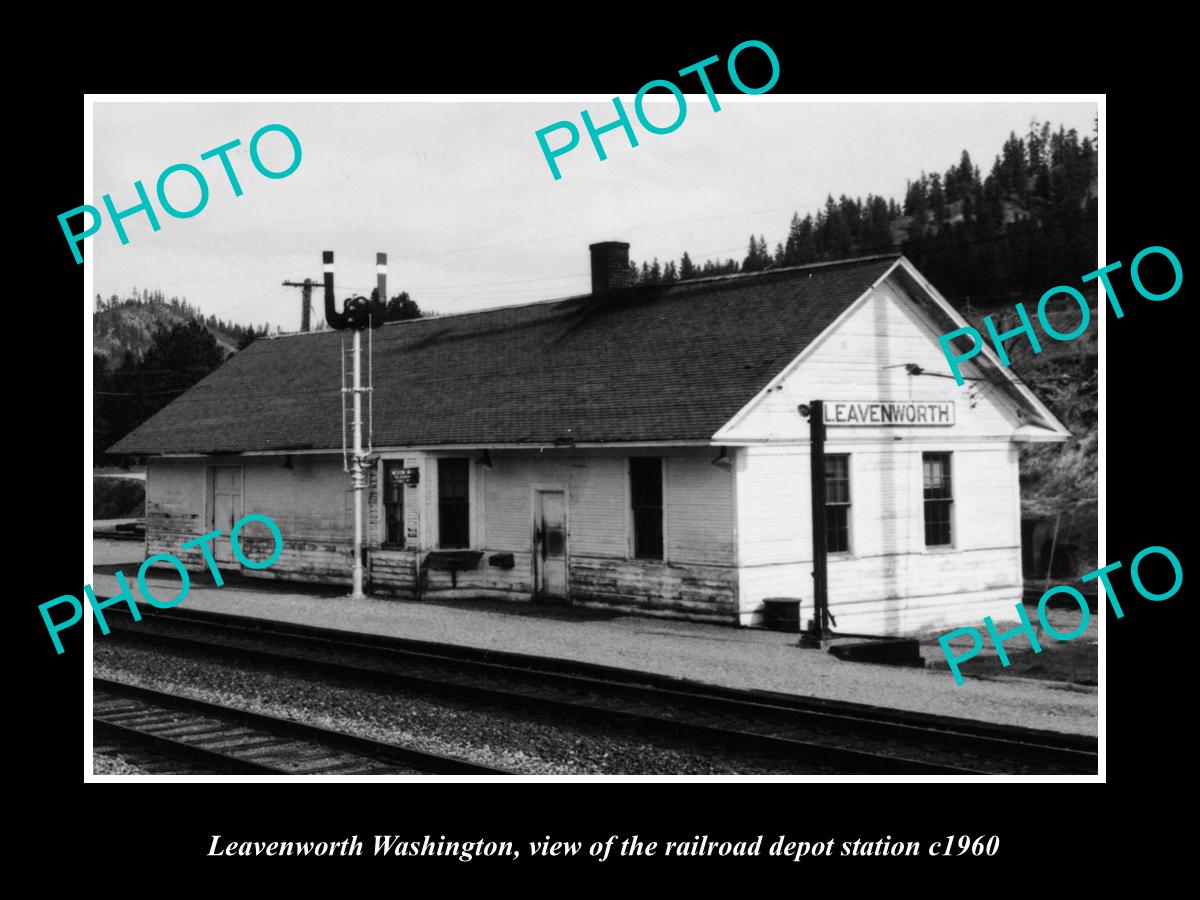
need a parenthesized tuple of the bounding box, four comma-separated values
(91, 677, 512, 775)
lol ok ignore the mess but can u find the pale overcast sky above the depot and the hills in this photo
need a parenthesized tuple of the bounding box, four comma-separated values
(86, 95, 1096, 331)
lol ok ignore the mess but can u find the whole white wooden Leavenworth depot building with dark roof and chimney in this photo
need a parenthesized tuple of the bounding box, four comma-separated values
(110, 242, 1068, 635)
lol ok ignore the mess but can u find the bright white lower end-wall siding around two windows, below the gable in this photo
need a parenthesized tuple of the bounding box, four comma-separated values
(737, 444, 1022, 634)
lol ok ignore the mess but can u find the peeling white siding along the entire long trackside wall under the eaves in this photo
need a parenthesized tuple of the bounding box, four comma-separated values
(148, 449, 737, 622)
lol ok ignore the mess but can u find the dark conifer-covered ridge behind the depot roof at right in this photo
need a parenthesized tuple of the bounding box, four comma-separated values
(630, 121, 1097, 307)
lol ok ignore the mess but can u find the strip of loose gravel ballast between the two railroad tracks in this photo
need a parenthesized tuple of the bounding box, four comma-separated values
(94, 638, 827, 775)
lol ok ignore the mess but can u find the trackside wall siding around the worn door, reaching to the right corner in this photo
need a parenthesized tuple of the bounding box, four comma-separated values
(422, 449, 737, 622)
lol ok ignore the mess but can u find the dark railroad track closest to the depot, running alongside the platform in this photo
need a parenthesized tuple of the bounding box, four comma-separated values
(106, 607, 1098, 775)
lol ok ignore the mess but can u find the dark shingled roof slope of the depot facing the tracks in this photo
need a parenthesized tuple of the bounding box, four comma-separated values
(109, 256, 898, 455)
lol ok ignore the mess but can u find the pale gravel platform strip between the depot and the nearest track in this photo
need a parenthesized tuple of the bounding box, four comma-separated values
(91, 541, 1098, 736)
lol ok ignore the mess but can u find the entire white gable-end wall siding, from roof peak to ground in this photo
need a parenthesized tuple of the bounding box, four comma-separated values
(719, 274, 1021, 634)
